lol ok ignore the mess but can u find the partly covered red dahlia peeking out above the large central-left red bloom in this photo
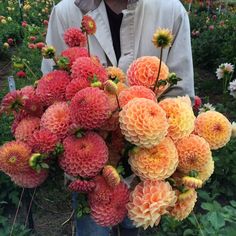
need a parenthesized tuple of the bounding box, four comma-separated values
(66, 78, 91, 100)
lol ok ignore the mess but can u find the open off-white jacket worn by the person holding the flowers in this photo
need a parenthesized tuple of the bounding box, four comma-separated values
(42, 0, 194, 98)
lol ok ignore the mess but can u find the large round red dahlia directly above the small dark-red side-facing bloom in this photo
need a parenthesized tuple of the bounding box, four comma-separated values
(60, 132, 108, 178)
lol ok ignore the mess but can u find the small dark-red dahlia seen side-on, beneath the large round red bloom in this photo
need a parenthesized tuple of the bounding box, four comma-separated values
(68, 179, 96, 193)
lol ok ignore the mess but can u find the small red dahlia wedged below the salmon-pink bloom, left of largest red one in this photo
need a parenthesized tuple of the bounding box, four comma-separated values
(28, 130, 58, 154)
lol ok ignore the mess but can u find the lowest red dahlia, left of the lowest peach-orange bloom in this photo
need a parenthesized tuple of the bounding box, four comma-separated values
(89, 176, 129, 227)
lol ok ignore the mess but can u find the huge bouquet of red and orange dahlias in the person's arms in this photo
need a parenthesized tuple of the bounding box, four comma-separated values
(0, 17, 232, 229)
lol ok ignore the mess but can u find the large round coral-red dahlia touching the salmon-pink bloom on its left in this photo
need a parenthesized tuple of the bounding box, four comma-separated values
(70, 87, 111, 129)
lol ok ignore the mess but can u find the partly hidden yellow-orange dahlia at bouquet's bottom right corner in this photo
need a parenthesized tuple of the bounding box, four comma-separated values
(170, 190, 197, 220)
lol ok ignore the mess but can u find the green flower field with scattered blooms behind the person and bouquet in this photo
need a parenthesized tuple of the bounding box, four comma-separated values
(0, 0, 236, 236)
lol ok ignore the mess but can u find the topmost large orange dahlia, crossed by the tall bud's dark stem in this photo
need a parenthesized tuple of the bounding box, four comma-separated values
(127, 56, 169, 91)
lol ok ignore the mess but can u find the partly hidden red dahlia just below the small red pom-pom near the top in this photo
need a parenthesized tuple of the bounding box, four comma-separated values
(61, 47, 88, 68)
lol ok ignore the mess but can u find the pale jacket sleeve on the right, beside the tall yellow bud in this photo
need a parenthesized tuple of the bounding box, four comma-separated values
(164, 9, 194, 101)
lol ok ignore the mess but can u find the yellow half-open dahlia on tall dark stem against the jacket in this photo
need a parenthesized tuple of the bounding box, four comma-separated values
(152, 28, 173, 48)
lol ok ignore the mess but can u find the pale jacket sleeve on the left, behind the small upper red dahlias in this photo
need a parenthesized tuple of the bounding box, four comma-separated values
(41, 6, 68, 74)
